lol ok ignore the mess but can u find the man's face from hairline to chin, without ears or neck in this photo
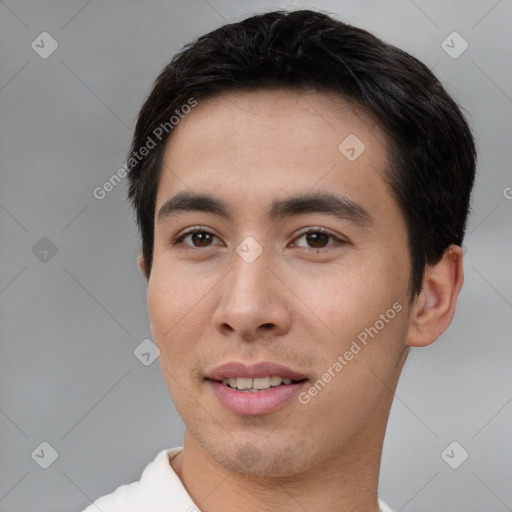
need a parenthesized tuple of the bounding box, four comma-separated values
(147, 90, 410, 476)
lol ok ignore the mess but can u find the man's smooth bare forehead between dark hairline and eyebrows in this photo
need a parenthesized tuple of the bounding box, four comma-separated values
(156, 89, 391, 222)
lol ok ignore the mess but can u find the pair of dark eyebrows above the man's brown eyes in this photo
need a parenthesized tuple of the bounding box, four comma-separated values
(158, 191, 373, 227)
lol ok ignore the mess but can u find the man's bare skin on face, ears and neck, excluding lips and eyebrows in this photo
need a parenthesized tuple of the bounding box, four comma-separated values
(138, 89, 463, 512)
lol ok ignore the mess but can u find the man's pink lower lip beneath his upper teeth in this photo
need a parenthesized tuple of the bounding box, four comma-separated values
(208, 380, 307, 416)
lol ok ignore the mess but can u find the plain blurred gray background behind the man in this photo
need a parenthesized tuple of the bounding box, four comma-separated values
(0, 0, 512, 512)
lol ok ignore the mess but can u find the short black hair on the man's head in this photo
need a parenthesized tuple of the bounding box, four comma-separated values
(128, 10, 476, 297)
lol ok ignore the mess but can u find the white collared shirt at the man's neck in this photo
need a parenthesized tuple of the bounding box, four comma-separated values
(83, 446, 393, 512)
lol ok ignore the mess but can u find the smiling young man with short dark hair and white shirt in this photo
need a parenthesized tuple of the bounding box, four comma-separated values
(81, 10, 475, 512)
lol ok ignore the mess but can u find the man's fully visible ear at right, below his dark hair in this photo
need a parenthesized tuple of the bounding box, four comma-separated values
(406, 245, 464, 347)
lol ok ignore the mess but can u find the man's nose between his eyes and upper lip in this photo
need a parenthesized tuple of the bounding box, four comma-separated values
(213, 247, 292, 341)
